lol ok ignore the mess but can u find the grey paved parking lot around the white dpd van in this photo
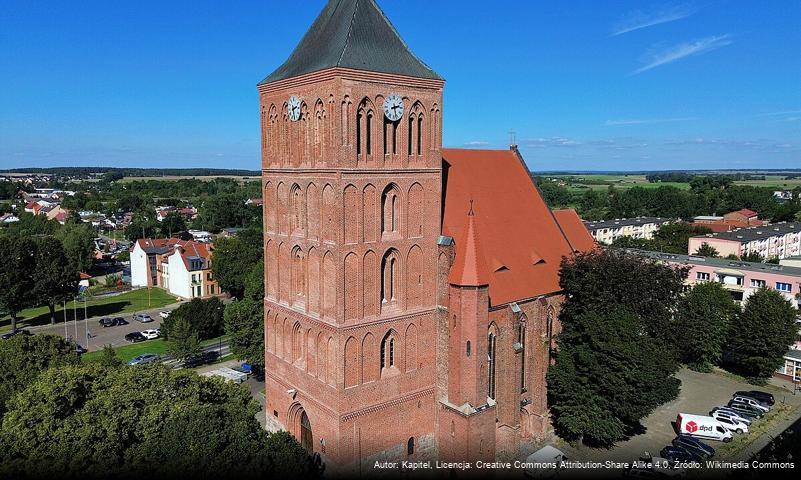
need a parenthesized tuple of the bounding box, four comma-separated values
(559, 369, 801, 462)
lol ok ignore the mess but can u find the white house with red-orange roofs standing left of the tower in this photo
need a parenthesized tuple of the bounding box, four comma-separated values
(130, 238, 222, 299)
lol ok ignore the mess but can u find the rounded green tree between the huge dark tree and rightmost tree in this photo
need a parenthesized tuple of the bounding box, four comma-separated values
(673, 282, 739, 372)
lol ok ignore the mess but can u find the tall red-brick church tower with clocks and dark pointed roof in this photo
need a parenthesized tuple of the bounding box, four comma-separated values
(258, 0, 444, 465)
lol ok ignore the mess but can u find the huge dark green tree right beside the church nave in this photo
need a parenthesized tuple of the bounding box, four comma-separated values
(547, 249, 687, 446)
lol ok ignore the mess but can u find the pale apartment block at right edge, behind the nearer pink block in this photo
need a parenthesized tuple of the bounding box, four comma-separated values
(687, 222, 801, 259)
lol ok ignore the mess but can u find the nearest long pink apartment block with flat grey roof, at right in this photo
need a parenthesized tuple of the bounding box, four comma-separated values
(636, 250, 801, 308)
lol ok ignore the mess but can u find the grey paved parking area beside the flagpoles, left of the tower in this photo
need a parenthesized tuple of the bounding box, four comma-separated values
(26, 302, 181, 352)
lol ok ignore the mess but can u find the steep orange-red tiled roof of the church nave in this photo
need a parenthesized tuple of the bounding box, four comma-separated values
(442, 148, 588, 305)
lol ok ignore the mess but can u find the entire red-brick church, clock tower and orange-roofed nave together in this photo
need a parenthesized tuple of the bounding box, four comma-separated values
(258, 0, 595, 470)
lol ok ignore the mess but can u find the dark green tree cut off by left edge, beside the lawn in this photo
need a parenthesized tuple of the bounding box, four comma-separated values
(0, 235, 36, 331)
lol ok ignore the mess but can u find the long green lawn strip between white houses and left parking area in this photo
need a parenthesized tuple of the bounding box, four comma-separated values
(0, 288, 177, 331)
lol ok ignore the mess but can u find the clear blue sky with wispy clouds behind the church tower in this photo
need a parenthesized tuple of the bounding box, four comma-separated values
(0, 0, 801, 170)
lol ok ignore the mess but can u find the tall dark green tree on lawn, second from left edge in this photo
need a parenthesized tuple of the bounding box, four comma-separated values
(33, 237, 80, 324)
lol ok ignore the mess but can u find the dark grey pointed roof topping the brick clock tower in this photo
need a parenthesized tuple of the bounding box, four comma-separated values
(259, 0, 442, 85)
